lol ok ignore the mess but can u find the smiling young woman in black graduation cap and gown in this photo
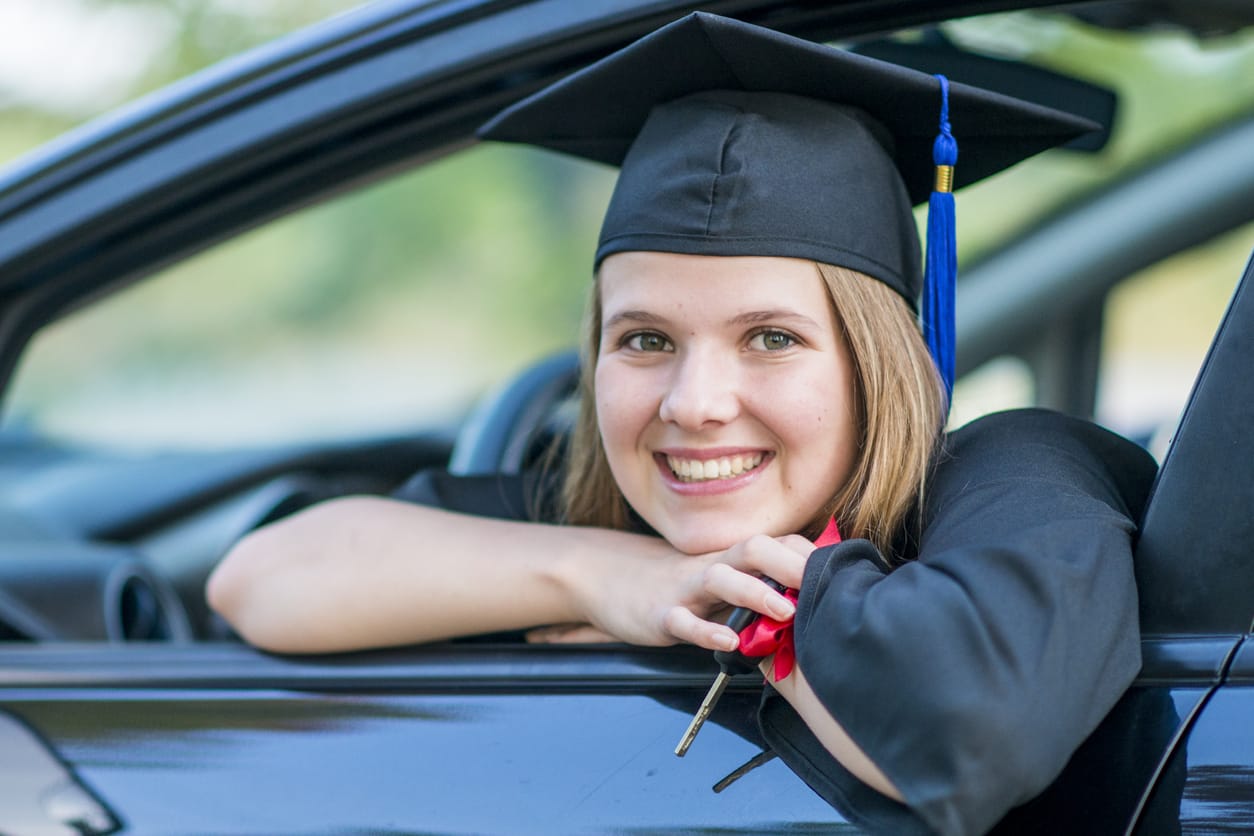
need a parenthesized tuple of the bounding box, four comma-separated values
(208, 15, 1154, 833)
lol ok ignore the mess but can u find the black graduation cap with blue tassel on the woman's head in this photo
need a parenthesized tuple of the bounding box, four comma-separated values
(479, 13, 1099, 398)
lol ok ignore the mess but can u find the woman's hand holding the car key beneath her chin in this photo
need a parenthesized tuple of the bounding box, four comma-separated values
(566, 535, 814, 651)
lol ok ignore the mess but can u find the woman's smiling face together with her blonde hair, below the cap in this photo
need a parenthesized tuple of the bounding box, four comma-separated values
(574, 252, 943, 554)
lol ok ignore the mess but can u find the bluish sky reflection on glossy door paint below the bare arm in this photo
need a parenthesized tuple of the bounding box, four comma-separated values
(9, 689, 859, 836)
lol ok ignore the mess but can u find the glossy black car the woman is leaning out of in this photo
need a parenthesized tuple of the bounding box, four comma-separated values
(0, 0, 1254, 836)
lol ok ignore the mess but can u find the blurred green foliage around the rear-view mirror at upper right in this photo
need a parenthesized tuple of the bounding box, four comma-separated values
(946, 13, 1254, 261)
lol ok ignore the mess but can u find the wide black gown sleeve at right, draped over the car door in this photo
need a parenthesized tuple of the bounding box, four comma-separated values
(760, 410, 1156, 836)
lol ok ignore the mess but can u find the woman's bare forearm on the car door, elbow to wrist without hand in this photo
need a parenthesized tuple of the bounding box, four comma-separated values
(208, 496, 652, 653)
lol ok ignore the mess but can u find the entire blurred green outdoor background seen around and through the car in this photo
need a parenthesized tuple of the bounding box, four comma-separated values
(0, 0, 1254, 449)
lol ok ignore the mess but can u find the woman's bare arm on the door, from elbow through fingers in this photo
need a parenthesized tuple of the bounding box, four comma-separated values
(207, 496, 803, 653)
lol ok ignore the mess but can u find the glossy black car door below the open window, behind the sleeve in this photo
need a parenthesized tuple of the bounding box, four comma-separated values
(0, 635, 1240, 833)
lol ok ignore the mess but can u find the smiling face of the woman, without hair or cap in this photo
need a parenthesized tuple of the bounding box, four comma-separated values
(596, 252, 858, 554)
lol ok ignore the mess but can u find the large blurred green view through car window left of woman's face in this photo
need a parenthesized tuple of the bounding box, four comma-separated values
(4, 145, 611, 449)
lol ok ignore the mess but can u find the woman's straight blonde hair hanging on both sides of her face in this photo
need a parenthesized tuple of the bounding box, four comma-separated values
(562, 263, 944, 559)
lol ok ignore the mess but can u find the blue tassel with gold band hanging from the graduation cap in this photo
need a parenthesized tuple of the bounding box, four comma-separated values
(923, 75, 958, 401)
